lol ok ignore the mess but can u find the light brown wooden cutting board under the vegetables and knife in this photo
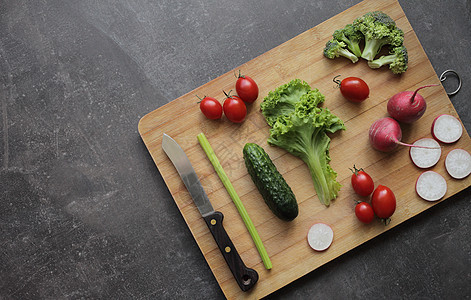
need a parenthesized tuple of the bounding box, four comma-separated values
(139, 0, 471, 299)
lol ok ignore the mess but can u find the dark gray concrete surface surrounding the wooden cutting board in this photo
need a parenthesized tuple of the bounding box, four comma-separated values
(0, 0, 471, 299)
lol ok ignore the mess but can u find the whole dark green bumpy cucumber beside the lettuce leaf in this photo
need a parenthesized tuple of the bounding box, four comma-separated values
(243, 143, 298, 221)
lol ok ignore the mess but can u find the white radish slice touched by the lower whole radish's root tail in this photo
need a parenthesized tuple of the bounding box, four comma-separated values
(409, 138, 442, 169)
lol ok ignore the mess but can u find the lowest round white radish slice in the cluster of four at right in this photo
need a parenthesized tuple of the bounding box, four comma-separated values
(415, 171, 447, 201)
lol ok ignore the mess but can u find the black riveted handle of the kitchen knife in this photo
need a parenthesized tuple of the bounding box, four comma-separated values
(203, 211, 258, 292)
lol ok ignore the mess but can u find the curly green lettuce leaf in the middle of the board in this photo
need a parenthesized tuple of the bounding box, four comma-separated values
(261, 79, 345, 206)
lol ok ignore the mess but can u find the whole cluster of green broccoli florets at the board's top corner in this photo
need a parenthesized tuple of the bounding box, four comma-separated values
(324, 11, 409, 74)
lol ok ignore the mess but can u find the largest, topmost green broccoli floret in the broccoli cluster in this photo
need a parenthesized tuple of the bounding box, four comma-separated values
(353, 11, 404, 60)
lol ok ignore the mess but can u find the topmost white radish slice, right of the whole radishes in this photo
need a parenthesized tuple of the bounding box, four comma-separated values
(432, 114, 463, 144)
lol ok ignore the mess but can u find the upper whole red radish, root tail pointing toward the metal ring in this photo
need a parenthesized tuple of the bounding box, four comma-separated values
(388, 84, 438, 123)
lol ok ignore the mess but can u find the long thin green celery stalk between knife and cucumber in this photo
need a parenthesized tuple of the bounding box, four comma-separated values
(197, 133, 272, 270)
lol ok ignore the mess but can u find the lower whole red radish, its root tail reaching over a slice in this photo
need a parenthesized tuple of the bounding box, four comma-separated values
(369, 117, 438, 152)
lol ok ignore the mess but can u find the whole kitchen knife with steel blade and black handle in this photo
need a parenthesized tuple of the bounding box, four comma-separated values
(162, 133, 258, 292)
